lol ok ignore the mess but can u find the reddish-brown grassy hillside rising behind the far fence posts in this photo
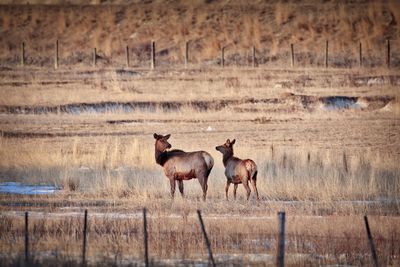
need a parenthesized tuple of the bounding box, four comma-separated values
(0, 0, 400, 67)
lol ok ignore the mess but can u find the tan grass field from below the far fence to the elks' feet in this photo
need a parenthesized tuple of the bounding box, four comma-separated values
(0, 68, 400, 201)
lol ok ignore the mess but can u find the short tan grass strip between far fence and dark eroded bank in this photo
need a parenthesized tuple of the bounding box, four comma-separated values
(0, 67, 400, 107)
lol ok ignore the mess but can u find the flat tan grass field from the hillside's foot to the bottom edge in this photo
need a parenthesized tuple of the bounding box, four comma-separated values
(0, 64, 400, 266)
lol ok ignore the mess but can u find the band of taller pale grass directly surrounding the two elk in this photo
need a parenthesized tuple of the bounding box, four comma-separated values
(1, 130, 400, 201)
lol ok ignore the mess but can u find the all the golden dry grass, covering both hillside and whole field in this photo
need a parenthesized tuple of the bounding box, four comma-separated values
(0, 1, 400, 266)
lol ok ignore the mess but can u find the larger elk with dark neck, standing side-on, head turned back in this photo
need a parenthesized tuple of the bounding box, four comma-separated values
(154, 133, 214, 200)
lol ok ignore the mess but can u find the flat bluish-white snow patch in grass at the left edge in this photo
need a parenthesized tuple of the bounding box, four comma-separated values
(0, 182, 59, 195)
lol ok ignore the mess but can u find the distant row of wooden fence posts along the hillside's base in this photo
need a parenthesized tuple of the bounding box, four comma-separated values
(12, 39, 393, 69)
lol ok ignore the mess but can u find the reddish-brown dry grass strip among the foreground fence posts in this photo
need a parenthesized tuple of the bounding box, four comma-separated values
(0, 211, 400, 266)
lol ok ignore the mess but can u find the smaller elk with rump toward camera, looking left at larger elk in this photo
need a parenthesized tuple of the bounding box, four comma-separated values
(215, 139, 260, 200)
